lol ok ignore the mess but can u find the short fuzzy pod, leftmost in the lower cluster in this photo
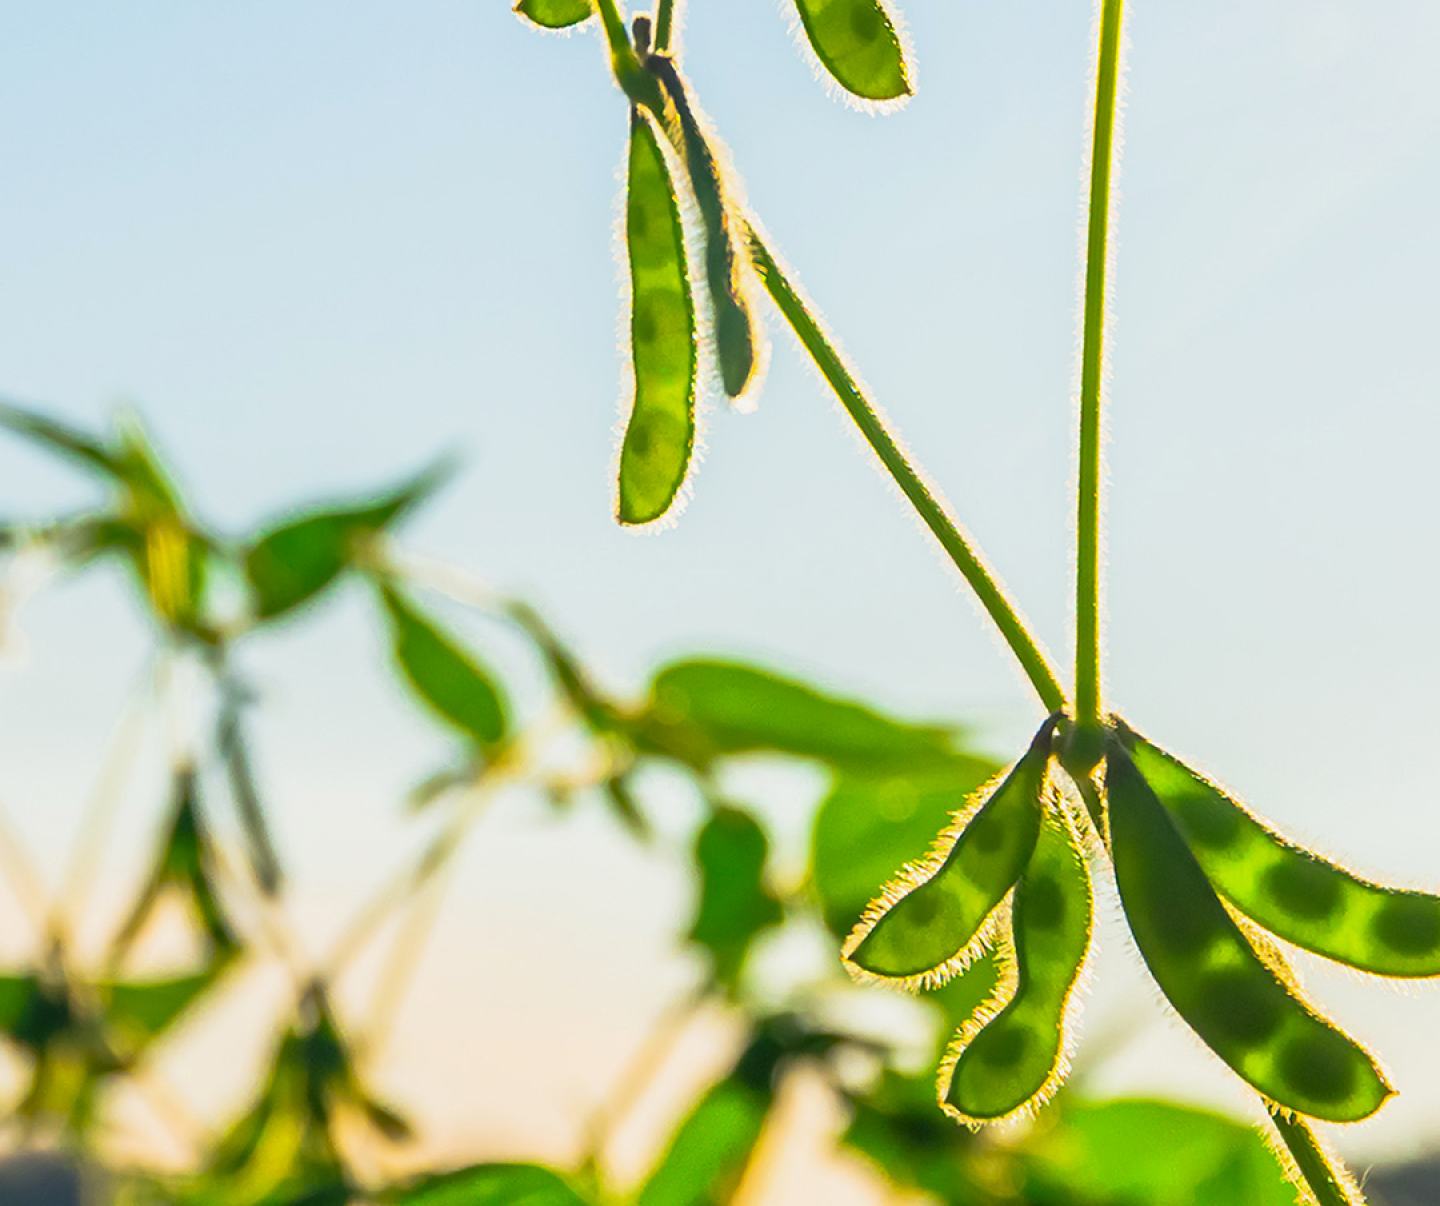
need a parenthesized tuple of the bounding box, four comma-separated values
(842, 722, 1051, 987)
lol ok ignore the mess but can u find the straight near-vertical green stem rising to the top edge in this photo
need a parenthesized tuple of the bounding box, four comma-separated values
(1076, 0, 1125, 724)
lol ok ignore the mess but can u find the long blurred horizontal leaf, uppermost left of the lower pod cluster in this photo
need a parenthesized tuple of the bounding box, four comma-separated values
(642, 658, 959, 773)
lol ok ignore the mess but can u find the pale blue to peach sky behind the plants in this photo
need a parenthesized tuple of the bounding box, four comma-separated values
(0, 0, 1440, 1197)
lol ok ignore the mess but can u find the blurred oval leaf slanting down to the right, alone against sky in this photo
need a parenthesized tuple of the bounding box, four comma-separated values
(380, 586, 510, 750)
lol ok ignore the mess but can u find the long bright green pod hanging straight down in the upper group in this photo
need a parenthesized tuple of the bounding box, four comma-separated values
(616, 109, 697, 524)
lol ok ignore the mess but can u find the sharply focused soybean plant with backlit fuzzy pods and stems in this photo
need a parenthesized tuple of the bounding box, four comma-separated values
(517, 0, 1440, 1205)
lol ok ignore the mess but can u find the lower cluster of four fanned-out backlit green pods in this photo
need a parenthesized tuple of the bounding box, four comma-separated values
(844, 728, 1440, 1124)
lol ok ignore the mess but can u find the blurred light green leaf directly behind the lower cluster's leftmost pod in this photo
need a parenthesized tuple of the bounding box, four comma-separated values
(811, 756, 999, 938)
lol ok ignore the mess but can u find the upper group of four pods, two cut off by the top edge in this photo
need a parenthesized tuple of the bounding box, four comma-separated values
(516, 0, 912, 525)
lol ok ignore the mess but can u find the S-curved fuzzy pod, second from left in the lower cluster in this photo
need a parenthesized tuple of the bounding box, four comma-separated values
(939, 809, 1094, 1125)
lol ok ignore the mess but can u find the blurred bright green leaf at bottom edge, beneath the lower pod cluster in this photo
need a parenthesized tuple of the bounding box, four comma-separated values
(1024, 1100, 1296, 1206)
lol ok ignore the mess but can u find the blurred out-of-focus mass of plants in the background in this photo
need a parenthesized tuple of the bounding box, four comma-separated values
(0, 404, 1292, 1206)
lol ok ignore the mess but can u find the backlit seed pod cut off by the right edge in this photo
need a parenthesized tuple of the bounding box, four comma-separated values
(1122, 730, 1440, 976)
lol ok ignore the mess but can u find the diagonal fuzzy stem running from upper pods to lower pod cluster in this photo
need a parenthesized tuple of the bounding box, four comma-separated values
(746, 225, 1066, 712)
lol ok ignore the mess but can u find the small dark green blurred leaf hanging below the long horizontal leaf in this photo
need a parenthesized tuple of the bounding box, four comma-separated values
(685, 806, 785, 989)
